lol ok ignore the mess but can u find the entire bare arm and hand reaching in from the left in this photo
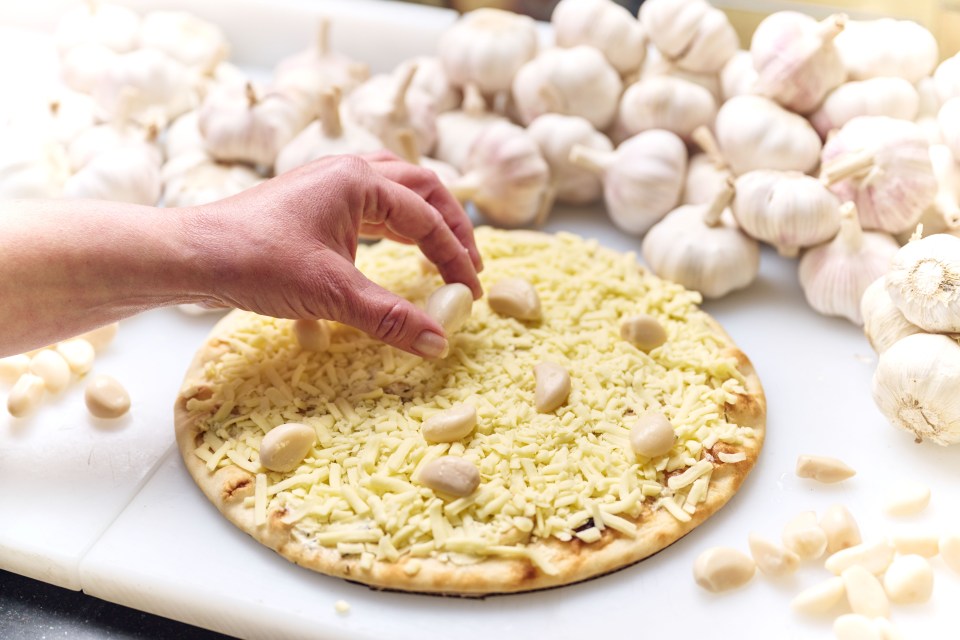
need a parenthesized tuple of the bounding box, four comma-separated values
(0, 154, 482, 357)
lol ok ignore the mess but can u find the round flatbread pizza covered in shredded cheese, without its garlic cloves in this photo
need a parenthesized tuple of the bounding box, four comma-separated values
(175, 228, 766, 596)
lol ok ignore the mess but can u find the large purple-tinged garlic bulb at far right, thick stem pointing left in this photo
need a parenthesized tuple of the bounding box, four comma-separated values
(821, 116, 937, 233)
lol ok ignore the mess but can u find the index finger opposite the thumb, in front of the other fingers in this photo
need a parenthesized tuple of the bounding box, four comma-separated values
(364, 171, 483, 298)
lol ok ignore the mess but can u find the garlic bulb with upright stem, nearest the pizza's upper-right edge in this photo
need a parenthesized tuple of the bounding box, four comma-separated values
(643, 181, 760, 298)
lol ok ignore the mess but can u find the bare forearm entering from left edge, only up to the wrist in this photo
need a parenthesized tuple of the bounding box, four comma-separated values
(0, 200, 204, 356)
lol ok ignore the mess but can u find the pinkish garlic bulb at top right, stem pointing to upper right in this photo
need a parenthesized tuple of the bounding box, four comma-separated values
(750, 11, 847, 113)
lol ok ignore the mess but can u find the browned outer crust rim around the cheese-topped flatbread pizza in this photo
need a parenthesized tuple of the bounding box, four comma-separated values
(174, 231, 766, 596)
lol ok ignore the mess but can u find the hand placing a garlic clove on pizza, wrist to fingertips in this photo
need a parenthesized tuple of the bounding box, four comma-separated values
(186, 153, 482, 357)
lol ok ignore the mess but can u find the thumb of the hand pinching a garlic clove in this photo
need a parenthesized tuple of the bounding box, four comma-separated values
(330, 255, 447, 358)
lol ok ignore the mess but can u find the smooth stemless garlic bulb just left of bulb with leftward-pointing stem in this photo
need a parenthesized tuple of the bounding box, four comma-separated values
(715, 96, 821, 175)
